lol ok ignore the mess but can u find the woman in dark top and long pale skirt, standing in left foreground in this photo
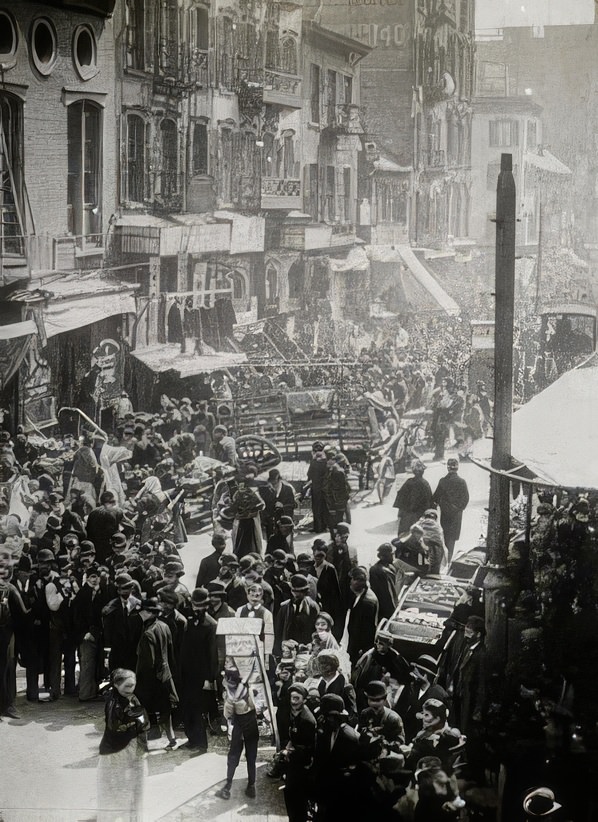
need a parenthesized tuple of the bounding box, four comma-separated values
(97, 668, 149, 822)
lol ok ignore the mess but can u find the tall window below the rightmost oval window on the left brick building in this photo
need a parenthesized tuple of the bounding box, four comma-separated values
(67, 100, 102, 245)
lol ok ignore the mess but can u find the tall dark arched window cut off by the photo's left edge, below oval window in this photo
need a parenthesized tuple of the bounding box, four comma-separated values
(0, 91, 25, 256)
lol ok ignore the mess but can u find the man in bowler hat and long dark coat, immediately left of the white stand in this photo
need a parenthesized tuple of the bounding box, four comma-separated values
(181, 588, 223, 754)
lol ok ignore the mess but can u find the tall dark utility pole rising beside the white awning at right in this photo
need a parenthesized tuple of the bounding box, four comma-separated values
(484, 154, 517, 687)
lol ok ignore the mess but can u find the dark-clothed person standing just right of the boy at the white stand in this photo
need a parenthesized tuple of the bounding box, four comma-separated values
(283, 683, 316, 822)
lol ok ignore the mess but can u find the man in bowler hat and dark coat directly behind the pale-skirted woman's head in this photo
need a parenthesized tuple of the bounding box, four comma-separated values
(102, 574, 143, 671)
